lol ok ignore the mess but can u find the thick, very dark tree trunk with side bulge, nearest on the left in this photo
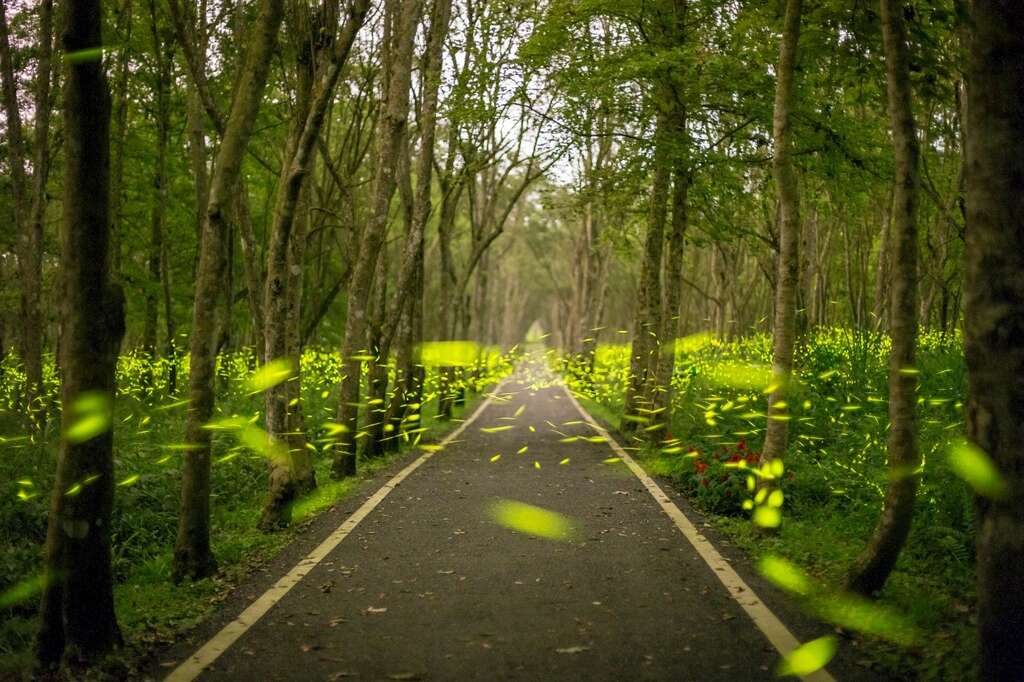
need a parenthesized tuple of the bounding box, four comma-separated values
(36, 0, 124, 667)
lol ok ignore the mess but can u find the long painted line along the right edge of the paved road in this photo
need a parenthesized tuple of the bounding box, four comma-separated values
(561, 383, 836, 682)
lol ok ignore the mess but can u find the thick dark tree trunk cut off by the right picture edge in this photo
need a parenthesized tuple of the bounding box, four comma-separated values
(965, 0, 1024, 682)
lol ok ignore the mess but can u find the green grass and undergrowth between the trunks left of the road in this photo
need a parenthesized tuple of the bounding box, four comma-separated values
(0, 349, 510, 678)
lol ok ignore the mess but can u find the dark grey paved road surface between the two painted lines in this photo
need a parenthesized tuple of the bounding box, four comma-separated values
(157, 364, 856, 681)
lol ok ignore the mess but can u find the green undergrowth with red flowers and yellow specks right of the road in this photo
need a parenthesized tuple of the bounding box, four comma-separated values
(561, 328, 977, 680)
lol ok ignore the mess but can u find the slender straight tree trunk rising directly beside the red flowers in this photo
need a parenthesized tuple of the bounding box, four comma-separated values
(763, 0, 803, 477)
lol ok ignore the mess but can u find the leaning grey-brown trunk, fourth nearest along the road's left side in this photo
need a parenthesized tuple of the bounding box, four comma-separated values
(332, 0, 420, 478)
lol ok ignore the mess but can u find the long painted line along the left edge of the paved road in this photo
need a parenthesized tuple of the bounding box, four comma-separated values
(164, 380, 507, 682)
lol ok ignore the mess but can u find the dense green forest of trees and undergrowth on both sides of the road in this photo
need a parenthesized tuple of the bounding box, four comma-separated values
(0, 0, 1024, 679)
